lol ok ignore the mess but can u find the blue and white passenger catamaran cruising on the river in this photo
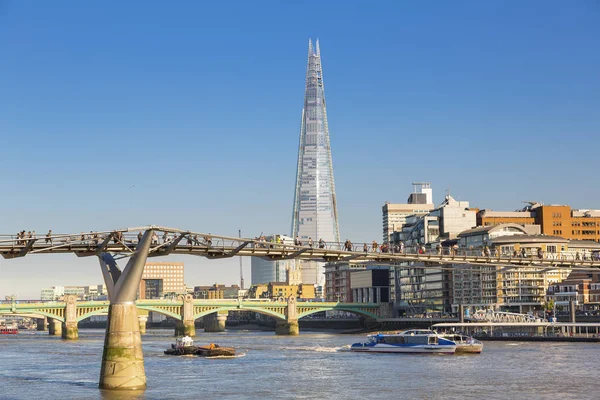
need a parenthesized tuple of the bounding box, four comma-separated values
(350, 329, 456, 354)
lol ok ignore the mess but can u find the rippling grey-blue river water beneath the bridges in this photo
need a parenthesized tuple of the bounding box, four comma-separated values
(0, 329, 600, 400)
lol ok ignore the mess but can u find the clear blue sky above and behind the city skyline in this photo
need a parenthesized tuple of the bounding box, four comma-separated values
(0, 0, 600, 299)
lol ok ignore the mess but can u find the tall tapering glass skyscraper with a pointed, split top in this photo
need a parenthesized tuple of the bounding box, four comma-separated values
(292, 40, 340, 255)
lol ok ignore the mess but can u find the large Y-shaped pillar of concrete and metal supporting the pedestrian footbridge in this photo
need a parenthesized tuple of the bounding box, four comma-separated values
(98, 229, 153, 390)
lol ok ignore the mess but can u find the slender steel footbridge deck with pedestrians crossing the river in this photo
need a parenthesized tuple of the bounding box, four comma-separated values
(0, 226, 600, 269)
